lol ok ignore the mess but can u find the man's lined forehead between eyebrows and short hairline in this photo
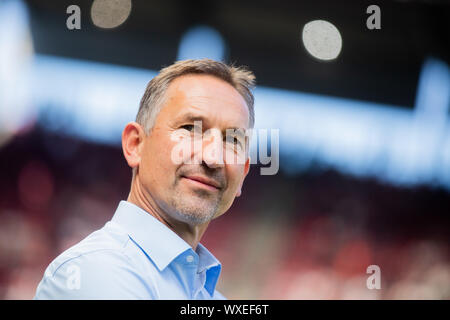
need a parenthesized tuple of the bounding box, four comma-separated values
(161, 74, 249, 128)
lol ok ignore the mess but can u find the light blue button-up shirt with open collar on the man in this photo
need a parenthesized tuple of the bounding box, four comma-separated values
(34, 201, 225, 300)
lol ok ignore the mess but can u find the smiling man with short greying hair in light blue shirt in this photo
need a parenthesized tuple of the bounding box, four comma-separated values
(35, 59, 254, 299)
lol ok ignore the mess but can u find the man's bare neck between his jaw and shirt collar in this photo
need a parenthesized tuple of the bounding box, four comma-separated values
(127, 174, 209, 251)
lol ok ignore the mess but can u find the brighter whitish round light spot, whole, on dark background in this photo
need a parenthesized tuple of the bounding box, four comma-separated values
(302, 20, 342, 60)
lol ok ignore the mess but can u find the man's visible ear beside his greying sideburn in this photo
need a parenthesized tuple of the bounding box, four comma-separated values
(122, 122, 145, 168)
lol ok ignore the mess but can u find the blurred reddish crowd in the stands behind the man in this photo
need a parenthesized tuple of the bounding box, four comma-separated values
(0, 128, 450, 299)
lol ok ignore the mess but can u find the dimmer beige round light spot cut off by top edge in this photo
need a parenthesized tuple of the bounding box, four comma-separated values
(91, 0, 131, 29)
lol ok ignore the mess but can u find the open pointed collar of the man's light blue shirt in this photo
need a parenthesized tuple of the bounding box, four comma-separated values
(111, 201, 221, 278)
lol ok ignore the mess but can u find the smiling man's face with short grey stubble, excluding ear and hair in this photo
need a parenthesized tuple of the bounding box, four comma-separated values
(138, 75, 249, 225)
